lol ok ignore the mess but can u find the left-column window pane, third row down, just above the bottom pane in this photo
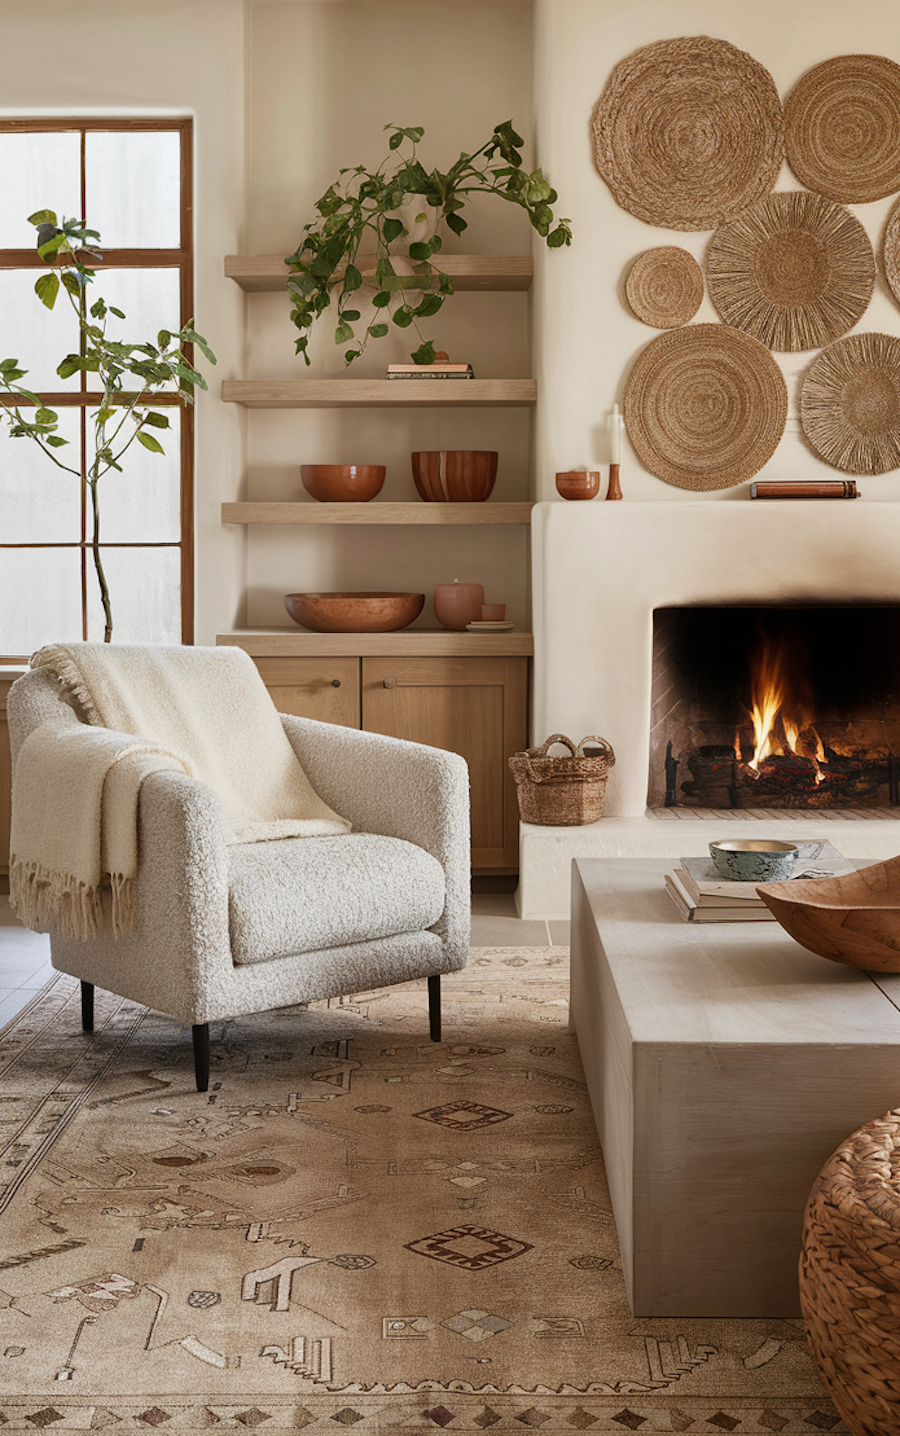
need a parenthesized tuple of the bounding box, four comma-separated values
(0, 409, 82, 542)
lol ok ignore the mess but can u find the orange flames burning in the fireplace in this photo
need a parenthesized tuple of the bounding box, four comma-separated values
(735, 635, 825, 783)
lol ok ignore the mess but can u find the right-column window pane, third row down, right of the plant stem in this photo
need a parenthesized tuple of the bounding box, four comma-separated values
(88, 405, 181, 543)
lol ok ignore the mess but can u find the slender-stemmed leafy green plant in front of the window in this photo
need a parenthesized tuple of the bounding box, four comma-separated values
(0, 210, 215, 643)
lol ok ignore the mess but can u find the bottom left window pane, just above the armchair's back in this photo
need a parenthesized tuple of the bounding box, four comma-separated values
(0, 549, 82, 655)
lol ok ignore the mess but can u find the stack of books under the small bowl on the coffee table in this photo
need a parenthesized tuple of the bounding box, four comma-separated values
(666, 841, 856, 922)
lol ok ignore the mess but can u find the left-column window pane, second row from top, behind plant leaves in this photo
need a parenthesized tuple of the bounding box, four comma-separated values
(0, 270, 79, 392)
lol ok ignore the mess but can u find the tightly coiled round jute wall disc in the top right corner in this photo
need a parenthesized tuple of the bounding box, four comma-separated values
(785, 55, 900, 204)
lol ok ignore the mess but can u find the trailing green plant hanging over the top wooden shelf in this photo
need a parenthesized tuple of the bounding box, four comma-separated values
(286, 121, 571, 365)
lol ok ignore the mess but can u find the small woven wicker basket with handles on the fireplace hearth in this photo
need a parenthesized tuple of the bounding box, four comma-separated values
(510, 732, 616, 827)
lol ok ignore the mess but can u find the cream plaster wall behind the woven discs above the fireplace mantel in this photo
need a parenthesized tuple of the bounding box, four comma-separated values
(534, 0, 900, 503)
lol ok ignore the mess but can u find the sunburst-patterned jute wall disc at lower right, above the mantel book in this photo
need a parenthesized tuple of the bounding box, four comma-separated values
(800, 335, 900, 474)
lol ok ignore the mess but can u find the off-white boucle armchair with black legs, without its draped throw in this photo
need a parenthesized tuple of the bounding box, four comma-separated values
(7, 669, 469, 1091)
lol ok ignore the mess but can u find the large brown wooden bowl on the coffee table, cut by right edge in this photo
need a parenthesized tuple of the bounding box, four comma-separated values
(756, 857, 900, 972)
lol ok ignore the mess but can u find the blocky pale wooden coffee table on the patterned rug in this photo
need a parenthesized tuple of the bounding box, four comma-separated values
(570, 859, 900, 1317)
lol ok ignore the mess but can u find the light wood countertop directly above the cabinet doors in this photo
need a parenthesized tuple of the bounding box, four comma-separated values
(215, 628, 534, 658)
